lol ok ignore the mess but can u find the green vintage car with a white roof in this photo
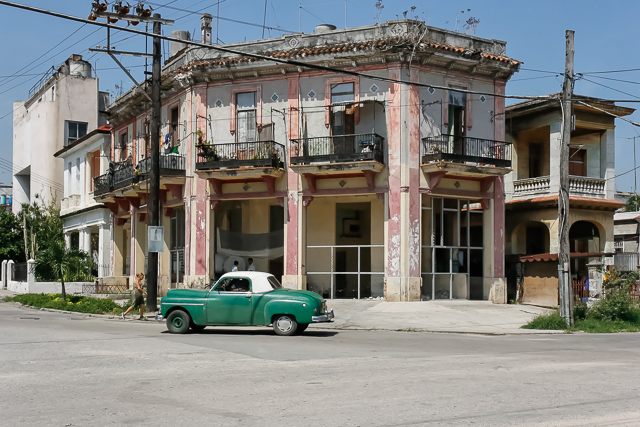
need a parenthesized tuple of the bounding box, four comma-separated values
(160, 271, 333, 335)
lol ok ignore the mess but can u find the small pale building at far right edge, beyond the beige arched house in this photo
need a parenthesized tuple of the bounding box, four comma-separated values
(613, 212, 640, 271)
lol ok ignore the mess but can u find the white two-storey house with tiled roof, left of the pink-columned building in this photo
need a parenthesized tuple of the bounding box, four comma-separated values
(54, 125, 111, 277)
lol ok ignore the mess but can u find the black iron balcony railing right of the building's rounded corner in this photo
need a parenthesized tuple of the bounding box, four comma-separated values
(422, 134, 512, 168)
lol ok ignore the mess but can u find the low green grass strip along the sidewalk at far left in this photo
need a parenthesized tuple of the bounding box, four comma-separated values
(4, 294, 130, 314)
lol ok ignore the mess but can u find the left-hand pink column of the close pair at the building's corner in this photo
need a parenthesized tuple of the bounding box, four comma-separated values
(386, 64, 402, 280)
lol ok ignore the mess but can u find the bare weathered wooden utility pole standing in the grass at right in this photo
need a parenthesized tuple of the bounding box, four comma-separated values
(558, 30, 575, 326)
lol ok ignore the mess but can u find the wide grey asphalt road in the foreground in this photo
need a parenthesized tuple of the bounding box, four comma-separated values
(0, 303, 640, 427)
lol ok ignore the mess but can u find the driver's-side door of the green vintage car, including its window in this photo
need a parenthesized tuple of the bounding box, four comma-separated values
(207, 277, 253, 325)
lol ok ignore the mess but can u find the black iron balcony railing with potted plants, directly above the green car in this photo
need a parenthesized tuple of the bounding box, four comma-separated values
(196, 141, 285, 170)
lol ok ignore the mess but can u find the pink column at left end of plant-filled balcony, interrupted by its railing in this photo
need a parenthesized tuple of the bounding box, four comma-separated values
(193, 84, 208, 276)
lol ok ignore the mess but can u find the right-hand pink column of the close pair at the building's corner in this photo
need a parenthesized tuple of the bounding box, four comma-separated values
(407, 66, 422, 280)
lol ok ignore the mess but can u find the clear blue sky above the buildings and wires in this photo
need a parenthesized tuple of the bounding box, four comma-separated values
(0, 0, 640, 191)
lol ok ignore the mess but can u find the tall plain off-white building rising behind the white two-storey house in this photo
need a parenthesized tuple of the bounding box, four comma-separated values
(13, 55, 109, 213)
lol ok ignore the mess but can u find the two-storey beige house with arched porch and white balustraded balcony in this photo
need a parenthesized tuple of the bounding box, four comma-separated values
(505, 94, 635, 306)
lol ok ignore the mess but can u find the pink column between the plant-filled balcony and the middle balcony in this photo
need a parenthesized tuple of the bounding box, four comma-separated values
(284, 76, 301, 276)
